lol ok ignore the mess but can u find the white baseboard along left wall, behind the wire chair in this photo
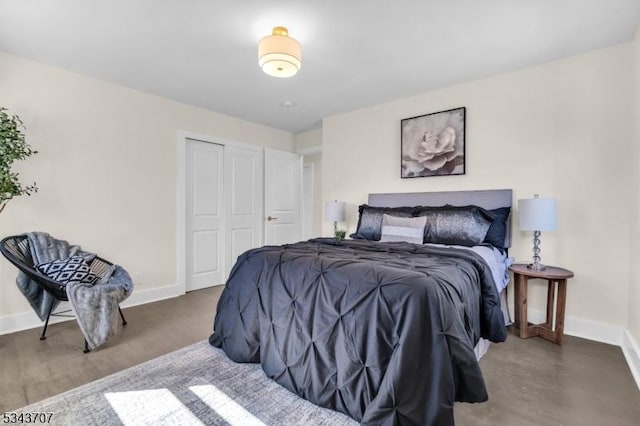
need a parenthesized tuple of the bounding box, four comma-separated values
(0, 284, 184, 335)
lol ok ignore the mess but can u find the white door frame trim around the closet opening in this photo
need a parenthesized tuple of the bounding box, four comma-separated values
(176, 130, 264, 295)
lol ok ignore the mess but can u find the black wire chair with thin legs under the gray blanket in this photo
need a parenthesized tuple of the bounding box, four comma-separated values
(0, 235, 127, 353)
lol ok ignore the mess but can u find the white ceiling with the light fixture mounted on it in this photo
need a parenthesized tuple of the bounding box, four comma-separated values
(0, 0, 640, 132)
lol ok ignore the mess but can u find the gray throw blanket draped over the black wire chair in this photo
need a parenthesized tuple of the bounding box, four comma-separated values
(16, 232, 133, 349)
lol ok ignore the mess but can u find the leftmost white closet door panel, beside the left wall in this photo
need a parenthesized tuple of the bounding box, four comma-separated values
(186, 139, 225, 291)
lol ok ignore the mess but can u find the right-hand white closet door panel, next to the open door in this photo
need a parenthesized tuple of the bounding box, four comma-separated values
(224, 145, 263, 279)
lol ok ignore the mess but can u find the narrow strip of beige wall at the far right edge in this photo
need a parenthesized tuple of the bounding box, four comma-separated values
(628, 27, 640, 348)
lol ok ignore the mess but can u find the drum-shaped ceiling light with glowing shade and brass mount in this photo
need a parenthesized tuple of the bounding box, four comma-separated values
(258, 27, 302, 77)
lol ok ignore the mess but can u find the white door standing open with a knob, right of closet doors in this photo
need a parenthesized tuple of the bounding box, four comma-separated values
(264, 149, 302, 245)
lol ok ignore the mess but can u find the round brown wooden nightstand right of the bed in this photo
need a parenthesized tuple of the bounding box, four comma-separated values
(509, 263, 573, 345)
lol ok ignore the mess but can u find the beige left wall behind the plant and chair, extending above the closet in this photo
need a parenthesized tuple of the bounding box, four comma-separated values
(0, 54, 294, 319)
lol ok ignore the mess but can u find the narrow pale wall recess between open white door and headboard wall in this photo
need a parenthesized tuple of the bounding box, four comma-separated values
(295, 129, 324, 237)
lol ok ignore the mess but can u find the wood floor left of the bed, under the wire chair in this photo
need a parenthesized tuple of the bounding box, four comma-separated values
(0, 286, 222, 413)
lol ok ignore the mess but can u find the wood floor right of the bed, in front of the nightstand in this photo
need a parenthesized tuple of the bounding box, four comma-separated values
(455, 327, 640, 426)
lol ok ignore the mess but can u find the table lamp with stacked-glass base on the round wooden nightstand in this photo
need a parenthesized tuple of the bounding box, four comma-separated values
(518, 194, 557, 271)
